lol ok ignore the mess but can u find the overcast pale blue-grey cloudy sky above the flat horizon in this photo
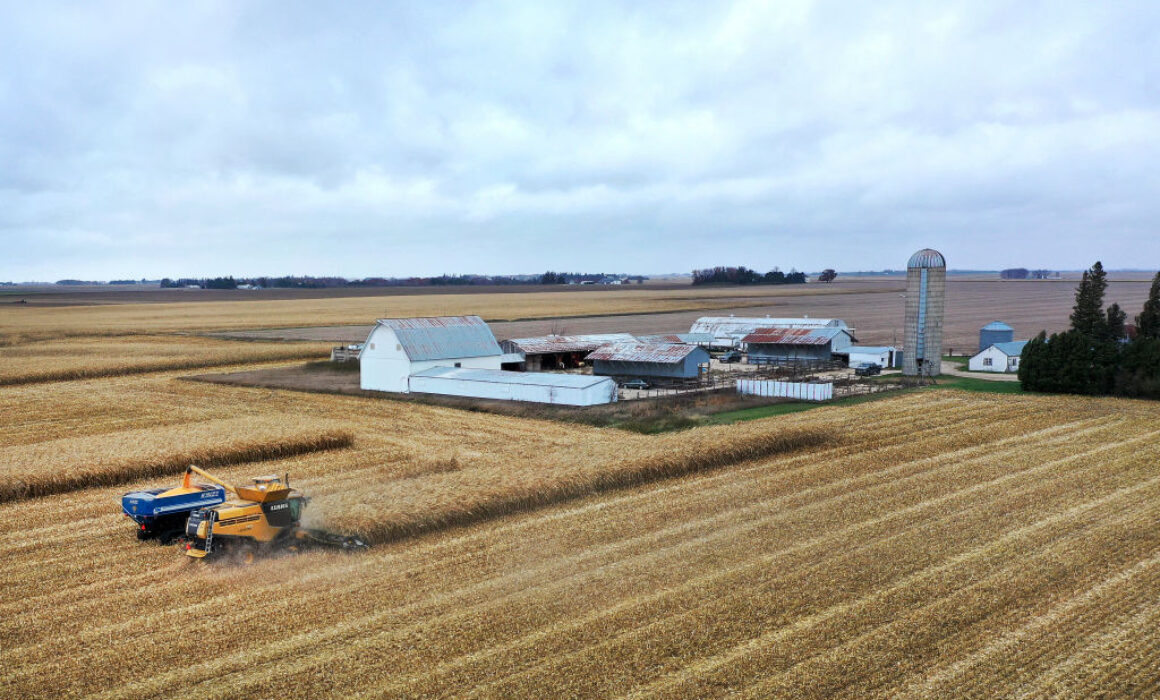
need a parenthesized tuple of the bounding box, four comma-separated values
(0, 0, 1160, 281)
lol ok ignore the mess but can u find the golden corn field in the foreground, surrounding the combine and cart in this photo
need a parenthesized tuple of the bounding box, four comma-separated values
(0, 364, 1160, 698)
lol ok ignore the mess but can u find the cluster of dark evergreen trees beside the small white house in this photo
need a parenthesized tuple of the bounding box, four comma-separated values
(1018, 262, 1160, 398)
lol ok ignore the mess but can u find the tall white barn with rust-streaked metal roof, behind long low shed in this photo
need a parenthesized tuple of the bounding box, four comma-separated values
(358, 316, 503, 392)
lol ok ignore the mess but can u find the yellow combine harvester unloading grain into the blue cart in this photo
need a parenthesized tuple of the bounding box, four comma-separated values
(184, 466, 367, 562)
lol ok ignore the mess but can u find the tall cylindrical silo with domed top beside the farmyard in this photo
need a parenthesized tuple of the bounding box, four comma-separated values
(902, 248, 947, 376)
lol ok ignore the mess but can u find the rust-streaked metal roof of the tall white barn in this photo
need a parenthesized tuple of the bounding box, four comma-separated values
(378, 316, 503, 361)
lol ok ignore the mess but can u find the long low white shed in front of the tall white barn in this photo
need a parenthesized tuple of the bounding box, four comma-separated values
(409, 367, 616, 406)
